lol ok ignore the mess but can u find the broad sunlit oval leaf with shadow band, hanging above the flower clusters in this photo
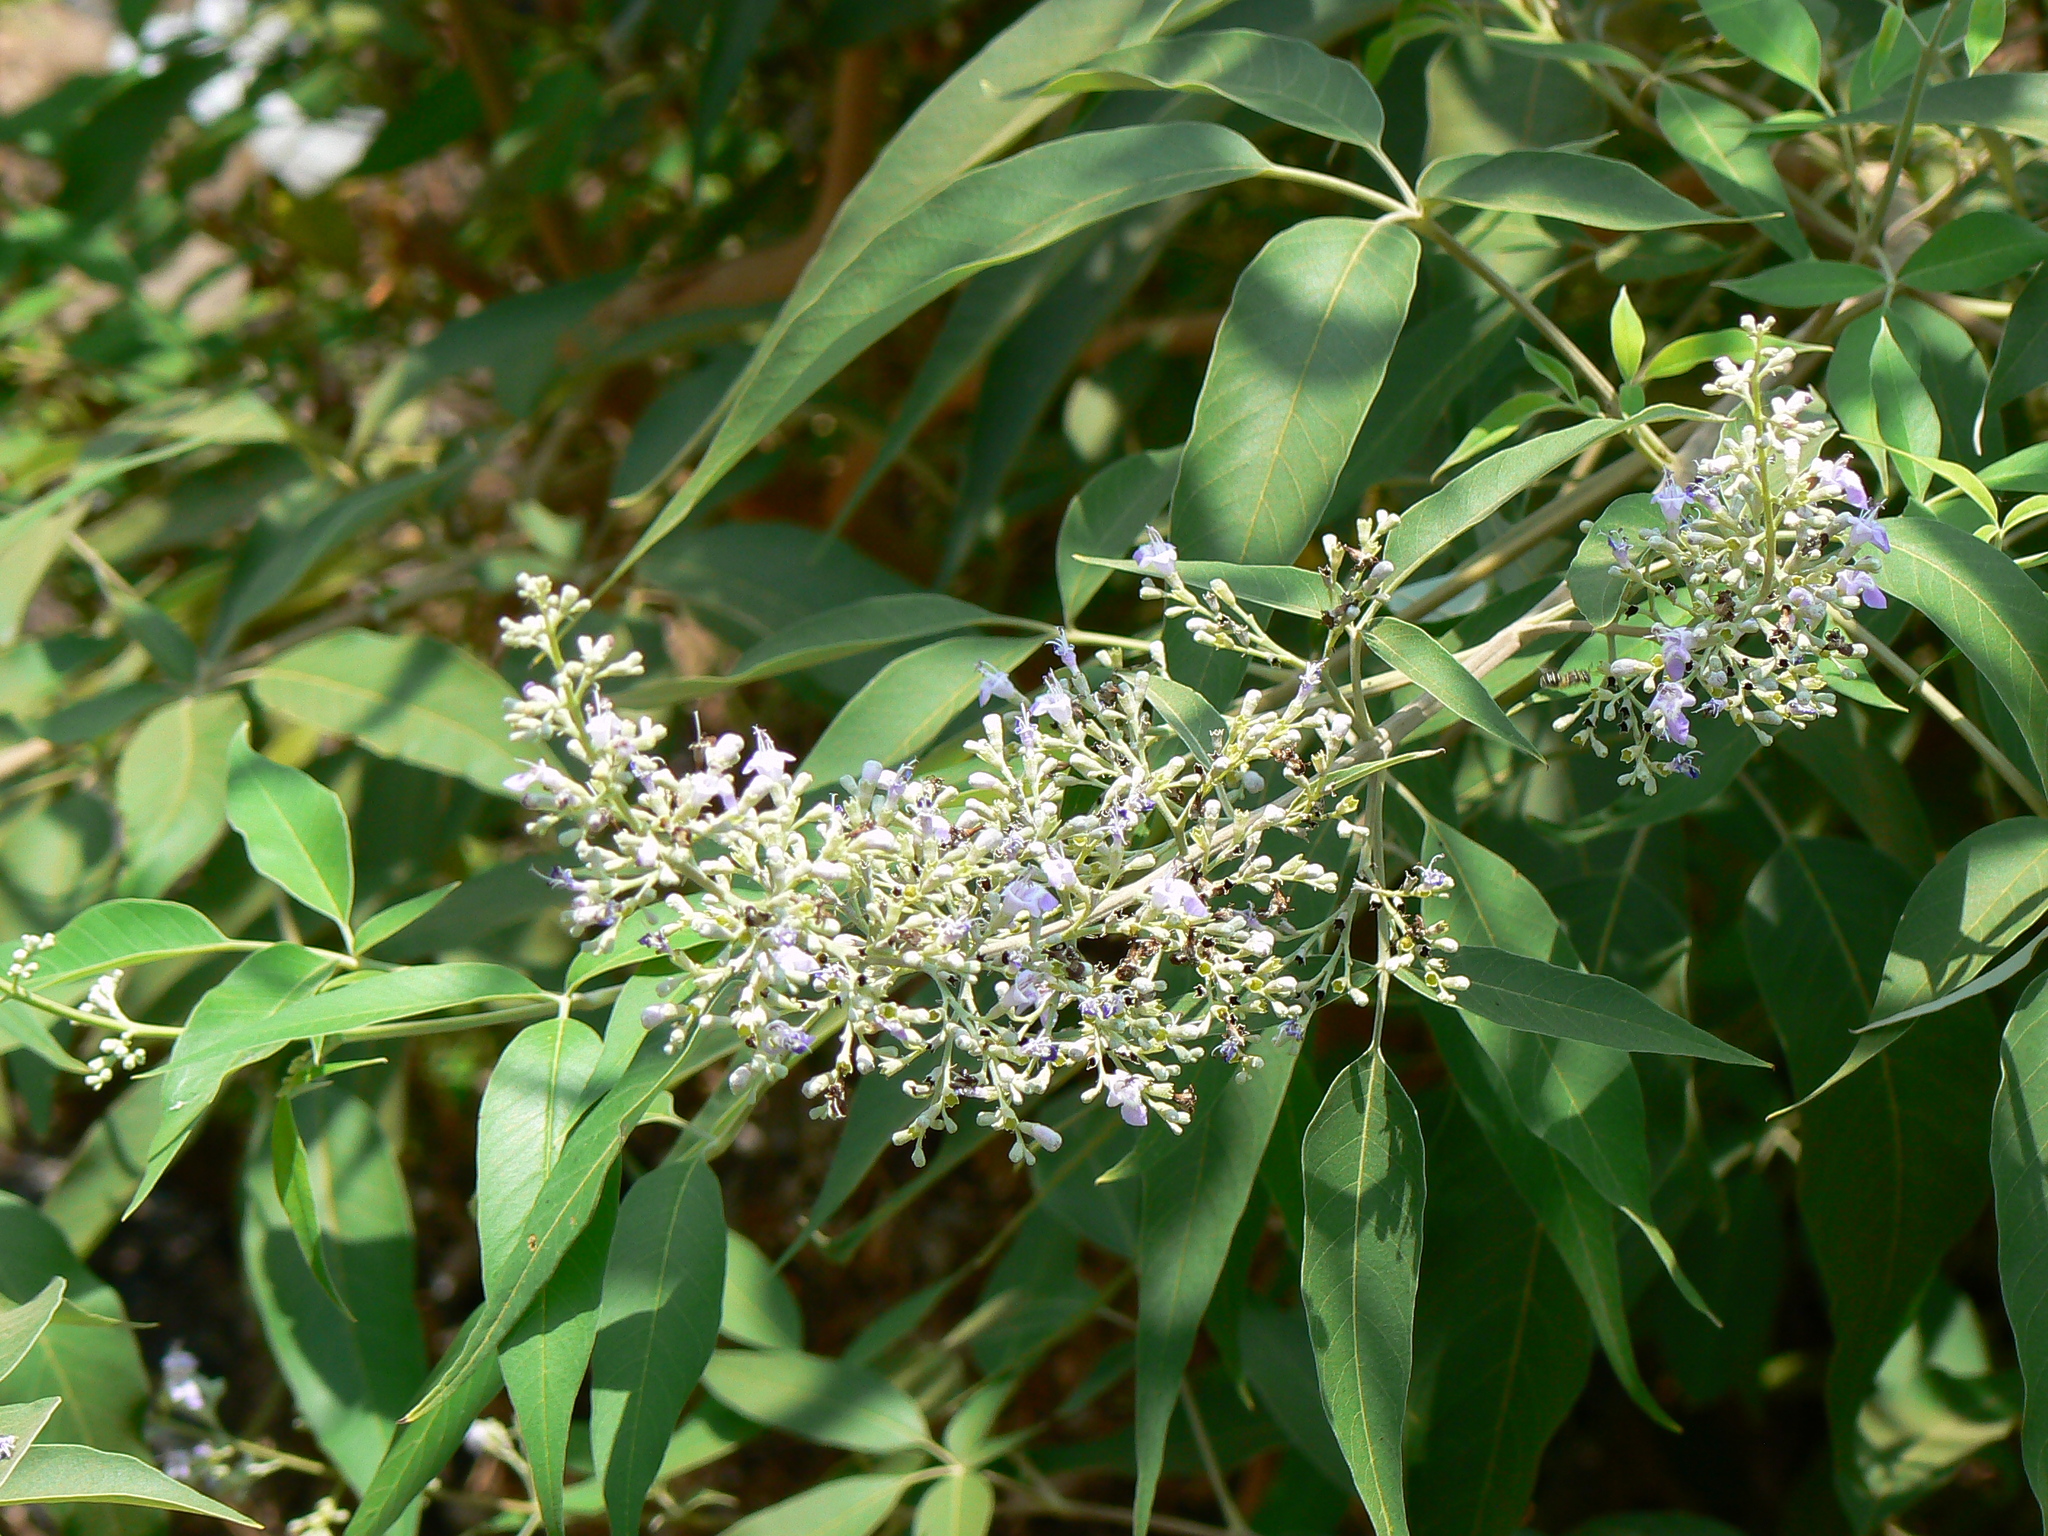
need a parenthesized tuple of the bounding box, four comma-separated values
(1174, 219, 1421, 565)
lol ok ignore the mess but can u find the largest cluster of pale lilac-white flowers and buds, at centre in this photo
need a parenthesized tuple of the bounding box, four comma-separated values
(504, 573, 1460, 1161)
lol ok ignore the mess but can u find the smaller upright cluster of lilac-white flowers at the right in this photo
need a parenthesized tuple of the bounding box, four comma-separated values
(1554, 315, 1890, 795)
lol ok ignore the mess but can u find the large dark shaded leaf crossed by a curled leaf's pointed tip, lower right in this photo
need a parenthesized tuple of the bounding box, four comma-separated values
(1743, 838, 1997, 1526)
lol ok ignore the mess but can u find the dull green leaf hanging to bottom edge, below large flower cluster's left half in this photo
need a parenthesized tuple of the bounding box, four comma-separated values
(590, 1155, 725, 1536)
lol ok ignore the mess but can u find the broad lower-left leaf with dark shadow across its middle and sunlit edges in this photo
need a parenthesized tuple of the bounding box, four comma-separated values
(242, 1083, 426, 1493)
